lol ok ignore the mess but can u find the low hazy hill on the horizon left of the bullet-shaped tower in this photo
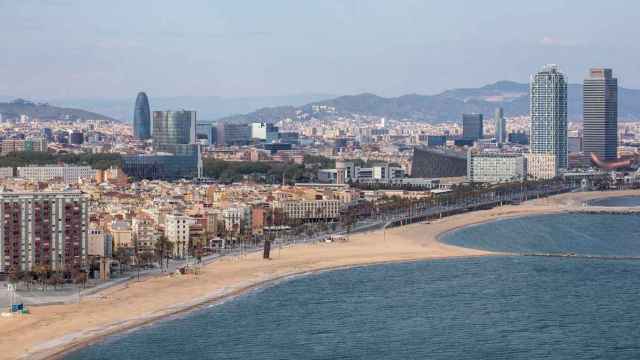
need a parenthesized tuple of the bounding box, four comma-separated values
(0, 99, 114, 121)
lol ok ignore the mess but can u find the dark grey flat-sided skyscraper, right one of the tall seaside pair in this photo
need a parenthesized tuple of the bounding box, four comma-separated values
(582, 68, 618, 160)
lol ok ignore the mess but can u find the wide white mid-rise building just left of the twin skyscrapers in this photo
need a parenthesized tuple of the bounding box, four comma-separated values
(467, 150, 527, 183)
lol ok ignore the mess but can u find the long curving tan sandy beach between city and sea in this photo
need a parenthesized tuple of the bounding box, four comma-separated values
(0, 191, 640, 359)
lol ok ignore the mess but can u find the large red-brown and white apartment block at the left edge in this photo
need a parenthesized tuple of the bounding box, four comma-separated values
(0, 192, 88, 272)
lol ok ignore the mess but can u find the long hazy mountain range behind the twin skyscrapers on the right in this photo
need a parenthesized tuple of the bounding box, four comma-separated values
(222, 81, 640, 122)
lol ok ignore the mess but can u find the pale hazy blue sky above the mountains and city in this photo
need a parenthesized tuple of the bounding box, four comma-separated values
(0, 0, 640, 98)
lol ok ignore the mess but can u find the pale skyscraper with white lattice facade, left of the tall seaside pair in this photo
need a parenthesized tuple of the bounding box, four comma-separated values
(529, 65, 568, 175)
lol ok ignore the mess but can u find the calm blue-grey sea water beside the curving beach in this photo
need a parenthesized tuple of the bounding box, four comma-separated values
(67, 215, 640, 360)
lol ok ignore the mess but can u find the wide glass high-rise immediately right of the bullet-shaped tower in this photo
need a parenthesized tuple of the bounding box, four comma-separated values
(152, 110, 196, 149)
